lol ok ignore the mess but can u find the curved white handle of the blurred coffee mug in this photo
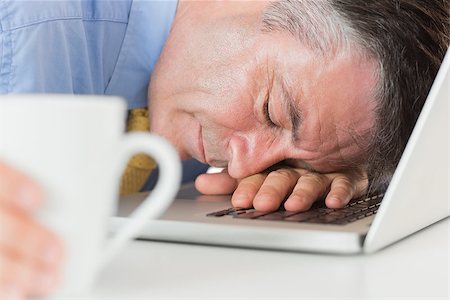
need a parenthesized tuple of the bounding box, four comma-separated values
(99, 132, 181, 268)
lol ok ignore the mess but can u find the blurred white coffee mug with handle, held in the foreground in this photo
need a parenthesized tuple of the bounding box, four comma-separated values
(0, 94, 181, 295)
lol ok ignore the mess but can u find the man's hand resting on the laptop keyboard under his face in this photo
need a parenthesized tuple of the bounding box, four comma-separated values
(195, 166, 368, 211)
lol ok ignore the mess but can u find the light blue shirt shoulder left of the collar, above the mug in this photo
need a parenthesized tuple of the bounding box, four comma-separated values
(0, 1, 128, 94)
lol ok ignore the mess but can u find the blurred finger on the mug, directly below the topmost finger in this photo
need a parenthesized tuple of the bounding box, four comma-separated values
(0, 205, 63, 267)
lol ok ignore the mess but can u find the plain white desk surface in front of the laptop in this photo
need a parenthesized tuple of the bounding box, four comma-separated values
(81, 218, 450, 300)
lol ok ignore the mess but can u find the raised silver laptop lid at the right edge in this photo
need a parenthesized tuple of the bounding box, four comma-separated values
(364, 50, 450, 252)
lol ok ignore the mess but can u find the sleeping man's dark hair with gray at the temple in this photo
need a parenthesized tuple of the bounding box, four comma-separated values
(263, 0, 450, 189)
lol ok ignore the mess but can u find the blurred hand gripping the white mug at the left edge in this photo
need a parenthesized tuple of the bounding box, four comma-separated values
(0, 161, 63, 299)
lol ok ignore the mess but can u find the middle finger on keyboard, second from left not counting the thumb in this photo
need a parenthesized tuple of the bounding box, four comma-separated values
(253, 168, 299, 211)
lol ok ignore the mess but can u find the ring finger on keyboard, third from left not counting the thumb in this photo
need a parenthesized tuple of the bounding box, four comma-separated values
(284, 173, 330, 211)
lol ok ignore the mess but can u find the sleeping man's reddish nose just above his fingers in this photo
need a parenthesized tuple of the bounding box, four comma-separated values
(228, 135, 284, 178)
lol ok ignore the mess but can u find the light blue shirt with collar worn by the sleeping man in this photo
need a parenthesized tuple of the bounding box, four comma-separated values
(0, 0, 177, 108)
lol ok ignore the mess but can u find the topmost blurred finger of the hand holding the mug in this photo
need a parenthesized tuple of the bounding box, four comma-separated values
(0, 161, 42, 211)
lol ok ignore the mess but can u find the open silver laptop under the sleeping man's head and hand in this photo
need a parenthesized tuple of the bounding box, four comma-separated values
(111, 51, 450, 254)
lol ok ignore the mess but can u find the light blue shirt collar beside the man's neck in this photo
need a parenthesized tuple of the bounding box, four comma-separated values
(105, 0, 178, 109)
